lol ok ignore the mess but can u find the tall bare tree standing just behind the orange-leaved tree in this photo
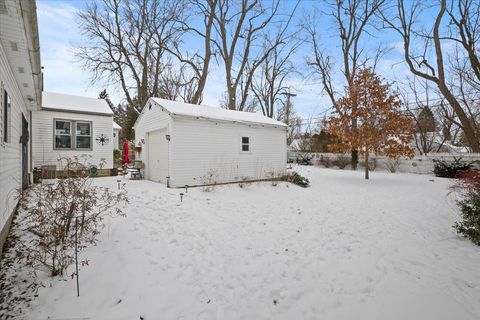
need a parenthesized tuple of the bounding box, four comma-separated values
(304, 0, 385, 169)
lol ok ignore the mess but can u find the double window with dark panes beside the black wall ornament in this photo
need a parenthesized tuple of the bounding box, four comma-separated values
(54, 119, 92, 150)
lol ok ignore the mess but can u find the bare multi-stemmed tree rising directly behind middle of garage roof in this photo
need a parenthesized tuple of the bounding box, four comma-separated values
(212, 0, 298, 111)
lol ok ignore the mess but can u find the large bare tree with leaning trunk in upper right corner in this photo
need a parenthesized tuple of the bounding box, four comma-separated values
(382, 0, 480, 152)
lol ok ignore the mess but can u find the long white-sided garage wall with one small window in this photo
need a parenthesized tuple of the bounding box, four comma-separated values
(170, 118, 287, 187)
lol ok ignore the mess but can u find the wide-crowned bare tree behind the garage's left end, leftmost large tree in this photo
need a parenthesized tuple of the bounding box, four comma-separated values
(76, 0, 190, 112)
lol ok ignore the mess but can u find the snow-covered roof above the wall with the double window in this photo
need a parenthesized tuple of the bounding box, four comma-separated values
(42, 92, 113, 115)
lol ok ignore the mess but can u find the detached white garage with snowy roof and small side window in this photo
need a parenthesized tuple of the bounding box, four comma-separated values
(134, 98, 287, 187)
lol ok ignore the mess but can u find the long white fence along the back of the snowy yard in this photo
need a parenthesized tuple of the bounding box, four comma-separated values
(288, 152, 480, 174)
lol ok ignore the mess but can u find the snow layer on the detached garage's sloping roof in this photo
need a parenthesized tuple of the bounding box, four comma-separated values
(151, 98, 287, 127)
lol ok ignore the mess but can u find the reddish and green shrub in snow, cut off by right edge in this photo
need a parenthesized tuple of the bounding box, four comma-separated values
(453, 170, 480, 245)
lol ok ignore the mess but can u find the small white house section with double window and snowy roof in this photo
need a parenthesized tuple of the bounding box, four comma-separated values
(32, 92, 114, 170)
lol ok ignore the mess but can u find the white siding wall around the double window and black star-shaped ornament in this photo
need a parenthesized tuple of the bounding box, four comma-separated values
(32, 110, 114, 170)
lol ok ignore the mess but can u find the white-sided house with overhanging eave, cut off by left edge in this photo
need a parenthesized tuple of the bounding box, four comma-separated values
(0, 0, 42, 253)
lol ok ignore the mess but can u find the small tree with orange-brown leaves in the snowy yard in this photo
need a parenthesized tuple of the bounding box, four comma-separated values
(327, 69, 415, 179)
